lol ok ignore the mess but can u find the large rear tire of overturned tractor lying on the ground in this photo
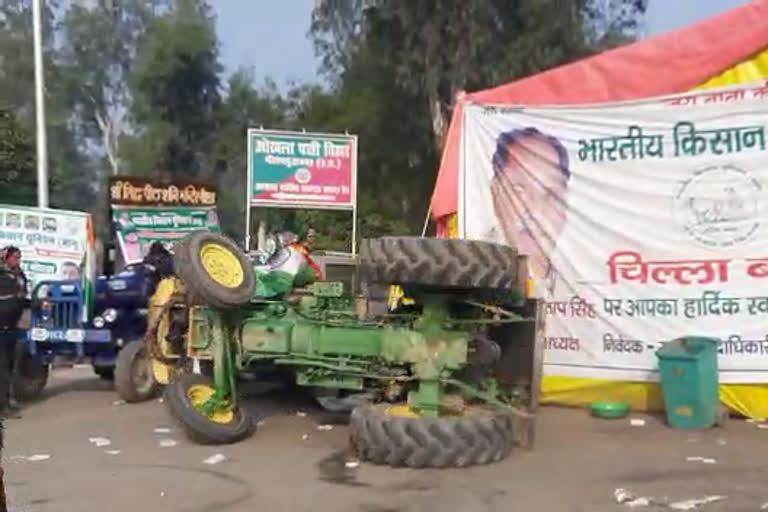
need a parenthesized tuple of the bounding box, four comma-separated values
(350, 404, 514, 468)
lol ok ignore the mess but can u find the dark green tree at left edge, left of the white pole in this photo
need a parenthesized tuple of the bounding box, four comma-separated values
(0, 110, 37, 206)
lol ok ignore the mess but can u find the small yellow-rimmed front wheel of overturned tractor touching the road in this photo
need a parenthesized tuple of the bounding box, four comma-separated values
(165, 373, 255, 444)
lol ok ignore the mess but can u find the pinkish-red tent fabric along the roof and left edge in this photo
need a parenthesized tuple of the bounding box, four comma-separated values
(432, 0, 768, 225)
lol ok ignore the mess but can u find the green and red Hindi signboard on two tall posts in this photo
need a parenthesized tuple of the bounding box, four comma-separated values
(245, 128, 357, 254)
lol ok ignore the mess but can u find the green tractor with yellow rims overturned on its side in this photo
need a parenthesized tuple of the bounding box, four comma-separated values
(146, 232, 532, 467)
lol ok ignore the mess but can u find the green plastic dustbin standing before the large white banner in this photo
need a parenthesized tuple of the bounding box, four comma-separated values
(656, 336, 720, 429)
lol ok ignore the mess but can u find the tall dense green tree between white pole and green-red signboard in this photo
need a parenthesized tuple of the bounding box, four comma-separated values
(123, 0, 222, 179)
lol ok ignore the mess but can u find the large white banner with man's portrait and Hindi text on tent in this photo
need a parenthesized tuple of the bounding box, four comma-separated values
(458, 81, 768, 383)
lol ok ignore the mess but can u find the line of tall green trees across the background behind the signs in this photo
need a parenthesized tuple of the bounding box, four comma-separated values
(0, 0, 646, 256)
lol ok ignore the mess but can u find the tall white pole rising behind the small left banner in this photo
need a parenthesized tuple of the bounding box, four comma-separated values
(32, 0, 48, 208)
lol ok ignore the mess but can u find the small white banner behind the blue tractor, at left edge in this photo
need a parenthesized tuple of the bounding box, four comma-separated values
(0, 205, 91, 291)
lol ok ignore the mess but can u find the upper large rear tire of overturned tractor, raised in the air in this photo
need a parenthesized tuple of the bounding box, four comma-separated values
(360, 237, 517, 290)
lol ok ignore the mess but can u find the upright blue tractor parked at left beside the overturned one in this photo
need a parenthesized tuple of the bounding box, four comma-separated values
(14, 256, 164, 402)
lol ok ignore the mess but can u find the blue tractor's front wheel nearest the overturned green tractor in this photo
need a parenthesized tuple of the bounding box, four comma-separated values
(115, 339, 160, 403)
